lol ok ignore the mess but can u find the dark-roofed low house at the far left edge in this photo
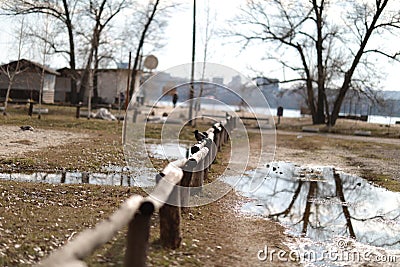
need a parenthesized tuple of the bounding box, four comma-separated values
(0, 59, 60, 103)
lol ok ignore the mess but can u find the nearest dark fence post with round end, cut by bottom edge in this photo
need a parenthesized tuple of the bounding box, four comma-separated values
(124, 201, 154, 267)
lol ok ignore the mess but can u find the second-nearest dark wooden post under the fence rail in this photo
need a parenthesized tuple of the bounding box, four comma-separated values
(156, 173, 182, 249)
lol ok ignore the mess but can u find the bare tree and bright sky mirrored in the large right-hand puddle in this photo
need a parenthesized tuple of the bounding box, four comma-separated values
(230, 164, 400, 249)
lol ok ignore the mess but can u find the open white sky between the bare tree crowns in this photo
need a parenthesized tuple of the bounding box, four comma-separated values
(0, 0, 400, 90)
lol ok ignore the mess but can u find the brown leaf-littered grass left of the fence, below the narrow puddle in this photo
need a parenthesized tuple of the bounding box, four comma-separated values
(0, 181, 143, 266)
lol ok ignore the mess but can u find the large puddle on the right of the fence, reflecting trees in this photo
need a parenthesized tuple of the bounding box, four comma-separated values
(225, 162, 400, 266)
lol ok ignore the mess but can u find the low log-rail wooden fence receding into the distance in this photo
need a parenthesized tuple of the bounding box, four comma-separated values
(37, 116, 236, 267)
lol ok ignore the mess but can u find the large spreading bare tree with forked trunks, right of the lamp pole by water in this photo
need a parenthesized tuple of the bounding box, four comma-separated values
(230, 0, 400, 125)
